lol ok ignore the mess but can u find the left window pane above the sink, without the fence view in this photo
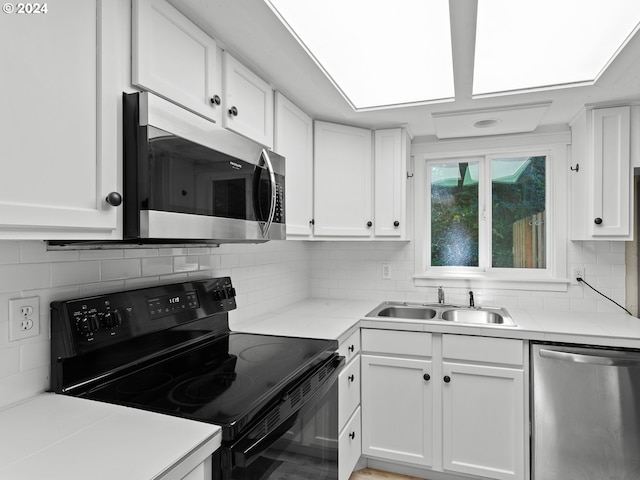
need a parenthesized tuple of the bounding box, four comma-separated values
(430, 161, 479, 267)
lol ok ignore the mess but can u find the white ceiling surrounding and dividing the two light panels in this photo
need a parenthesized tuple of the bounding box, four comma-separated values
(169, 0, 640, 137)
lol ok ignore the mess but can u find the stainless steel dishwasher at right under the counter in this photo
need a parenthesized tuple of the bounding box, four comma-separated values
(531, 344, 640, 480)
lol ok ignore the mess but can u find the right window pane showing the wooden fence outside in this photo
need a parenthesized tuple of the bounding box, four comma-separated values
(491, 156, 547, 269)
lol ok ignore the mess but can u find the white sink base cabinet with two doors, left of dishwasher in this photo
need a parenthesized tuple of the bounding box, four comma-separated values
(361, 329, 528, 480)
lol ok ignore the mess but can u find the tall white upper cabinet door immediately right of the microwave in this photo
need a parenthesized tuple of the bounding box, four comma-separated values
(274, 92, 313, 237)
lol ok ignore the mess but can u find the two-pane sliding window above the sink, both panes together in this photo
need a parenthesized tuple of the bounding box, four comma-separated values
(427, 155, 547, 270)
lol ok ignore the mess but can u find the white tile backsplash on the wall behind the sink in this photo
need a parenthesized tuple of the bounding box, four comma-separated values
(311, 242, 625, 312)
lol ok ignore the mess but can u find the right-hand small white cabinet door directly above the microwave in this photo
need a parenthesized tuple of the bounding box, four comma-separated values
(222, 52, 273, 148)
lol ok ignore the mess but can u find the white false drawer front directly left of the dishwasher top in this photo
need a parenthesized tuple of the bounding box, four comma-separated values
(442, 335, 524, 365)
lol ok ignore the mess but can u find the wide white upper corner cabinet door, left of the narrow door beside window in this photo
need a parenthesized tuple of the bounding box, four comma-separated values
(314, 122, 373, 237)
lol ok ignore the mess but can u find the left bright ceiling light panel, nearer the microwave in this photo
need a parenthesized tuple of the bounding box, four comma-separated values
(265, 0, 454, 109)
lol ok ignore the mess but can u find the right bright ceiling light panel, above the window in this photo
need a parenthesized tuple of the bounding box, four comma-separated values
(473, 0, 640, 95)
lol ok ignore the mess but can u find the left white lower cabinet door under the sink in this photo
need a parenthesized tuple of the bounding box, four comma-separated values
(361, 355, 433, 466)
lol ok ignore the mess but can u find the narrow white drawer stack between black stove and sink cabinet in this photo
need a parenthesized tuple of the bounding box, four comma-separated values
(338, 330, 361, 480)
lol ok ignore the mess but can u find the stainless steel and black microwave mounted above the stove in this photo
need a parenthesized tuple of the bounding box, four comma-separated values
(123, 92, 286, 243)
